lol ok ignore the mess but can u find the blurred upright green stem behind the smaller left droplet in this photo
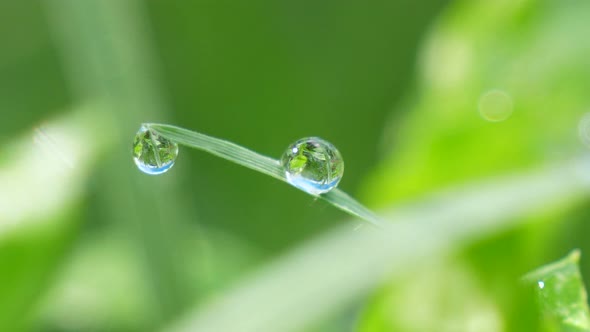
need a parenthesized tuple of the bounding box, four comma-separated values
(44, 0, 196, 326)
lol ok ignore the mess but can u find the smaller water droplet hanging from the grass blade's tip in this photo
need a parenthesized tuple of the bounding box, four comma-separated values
(133, 126, 178, 175)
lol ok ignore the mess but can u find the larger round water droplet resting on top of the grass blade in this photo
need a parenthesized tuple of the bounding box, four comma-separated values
(281, 137, 344, 195)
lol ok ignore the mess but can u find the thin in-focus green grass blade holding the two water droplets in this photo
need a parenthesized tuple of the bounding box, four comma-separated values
(145, 123, 385, 226)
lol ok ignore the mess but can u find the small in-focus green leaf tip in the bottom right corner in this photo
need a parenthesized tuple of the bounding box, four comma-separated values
(524, 250, 590, 331)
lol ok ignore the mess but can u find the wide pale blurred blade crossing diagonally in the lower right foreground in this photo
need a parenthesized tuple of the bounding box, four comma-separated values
(164, 159, 590, 332)
